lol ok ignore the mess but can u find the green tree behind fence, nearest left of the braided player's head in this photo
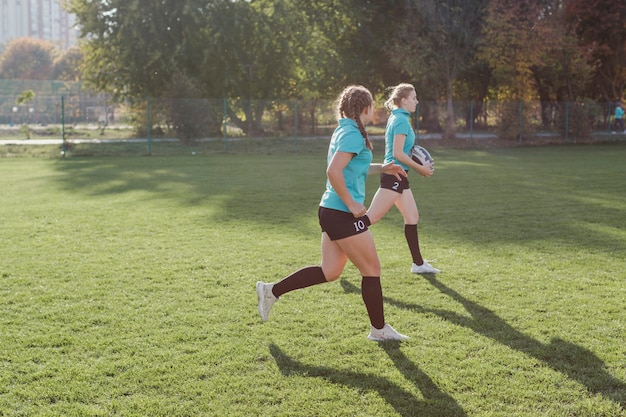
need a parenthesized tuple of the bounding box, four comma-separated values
(200, 0, 302, 134)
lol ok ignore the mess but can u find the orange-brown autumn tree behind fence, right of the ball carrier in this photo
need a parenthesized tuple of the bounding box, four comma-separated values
(481, 0, 592, 136)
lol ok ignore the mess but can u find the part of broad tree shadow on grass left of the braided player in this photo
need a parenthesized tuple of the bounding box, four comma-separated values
(50, 155, 324, 228)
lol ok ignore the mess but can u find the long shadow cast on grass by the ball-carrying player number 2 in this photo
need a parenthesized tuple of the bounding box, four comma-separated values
(341, 274, 626, 409)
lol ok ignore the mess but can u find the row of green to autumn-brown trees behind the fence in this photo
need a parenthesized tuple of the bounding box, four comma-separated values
(0, 0, 626, 140)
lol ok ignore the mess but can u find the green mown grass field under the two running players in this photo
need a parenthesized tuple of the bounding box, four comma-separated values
(0, 143, 626, 417)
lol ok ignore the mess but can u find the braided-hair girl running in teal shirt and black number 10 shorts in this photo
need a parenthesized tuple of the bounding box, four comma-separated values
(256, 86, 408, 341)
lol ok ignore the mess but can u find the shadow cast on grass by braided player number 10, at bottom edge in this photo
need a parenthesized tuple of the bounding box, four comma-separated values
(270, 343, 466, 417)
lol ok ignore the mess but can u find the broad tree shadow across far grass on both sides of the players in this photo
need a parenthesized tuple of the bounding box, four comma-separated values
(50, 146, 626, 256)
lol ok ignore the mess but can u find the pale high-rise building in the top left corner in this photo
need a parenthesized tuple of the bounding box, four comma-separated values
(0, 0, 76, 49)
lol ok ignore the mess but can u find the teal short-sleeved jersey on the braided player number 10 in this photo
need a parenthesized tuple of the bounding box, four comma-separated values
(320, 118, 373, 213)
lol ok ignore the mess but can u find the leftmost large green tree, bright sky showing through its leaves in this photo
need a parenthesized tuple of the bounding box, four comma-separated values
(67, 0, 193, 98)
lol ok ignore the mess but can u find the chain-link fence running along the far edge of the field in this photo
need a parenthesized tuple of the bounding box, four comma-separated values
(0, 84, 624, 153)
